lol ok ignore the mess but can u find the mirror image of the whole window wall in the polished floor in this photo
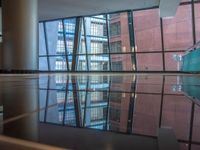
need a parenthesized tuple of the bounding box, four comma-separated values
(0, 74, 200, 150)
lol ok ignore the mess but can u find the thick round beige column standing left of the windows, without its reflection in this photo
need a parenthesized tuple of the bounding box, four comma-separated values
(1, 0, 38, 71)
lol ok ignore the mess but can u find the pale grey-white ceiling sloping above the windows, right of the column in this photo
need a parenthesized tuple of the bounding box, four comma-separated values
(38, 0, 160, 21)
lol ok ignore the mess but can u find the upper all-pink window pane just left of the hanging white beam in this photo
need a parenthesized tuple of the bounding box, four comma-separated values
(133, 9, 161, 52)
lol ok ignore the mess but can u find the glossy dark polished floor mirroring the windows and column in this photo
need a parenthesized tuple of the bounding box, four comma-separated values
(0, 74, 200, 150)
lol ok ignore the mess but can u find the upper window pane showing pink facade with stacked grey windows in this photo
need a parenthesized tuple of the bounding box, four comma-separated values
(108, 12, 131, 53)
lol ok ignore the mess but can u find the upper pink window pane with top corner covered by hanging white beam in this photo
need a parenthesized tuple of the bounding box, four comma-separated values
(163, 5, 193, 51)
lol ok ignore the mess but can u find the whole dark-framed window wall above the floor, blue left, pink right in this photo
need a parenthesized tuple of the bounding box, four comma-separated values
(39, 1, 200, 72)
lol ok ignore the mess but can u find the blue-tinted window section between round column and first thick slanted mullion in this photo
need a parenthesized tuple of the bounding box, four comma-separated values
(39, 19, 76, 71)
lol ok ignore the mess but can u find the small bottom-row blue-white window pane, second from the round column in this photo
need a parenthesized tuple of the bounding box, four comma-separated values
(49, 56, 67, 71)
